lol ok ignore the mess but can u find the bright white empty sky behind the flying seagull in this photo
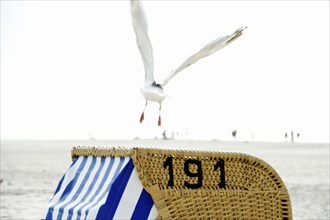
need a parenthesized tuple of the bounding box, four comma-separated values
(1, 1, 329, 142)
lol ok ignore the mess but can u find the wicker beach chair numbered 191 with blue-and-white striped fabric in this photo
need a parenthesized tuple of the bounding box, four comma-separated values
(45, 147, 292, 219)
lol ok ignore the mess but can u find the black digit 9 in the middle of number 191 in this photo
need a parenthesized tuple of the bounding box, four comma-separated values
(184, 160, 203, 189)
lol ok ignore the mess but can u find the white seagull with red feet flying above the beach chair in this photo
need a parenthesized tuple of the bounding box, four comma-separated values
(131, 0, 246, 126)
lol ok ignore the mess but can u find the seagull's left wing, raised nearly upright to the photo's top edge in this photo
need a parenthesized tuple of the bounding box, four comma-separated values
(131, 0, 154, 84)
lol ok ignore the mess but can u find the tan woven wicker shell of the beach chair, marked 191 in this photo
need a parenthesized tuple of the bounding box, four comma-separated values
(72, 147, 292, 219)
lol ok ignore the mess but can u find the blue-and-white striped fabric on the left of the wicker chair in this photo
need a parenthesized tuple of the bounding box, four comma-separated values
(45, 156, 158, 220)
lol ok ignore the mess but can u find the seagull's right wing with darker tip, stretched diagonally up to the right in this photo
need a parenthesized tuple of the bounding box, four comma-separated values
(161, 27, 246, 86)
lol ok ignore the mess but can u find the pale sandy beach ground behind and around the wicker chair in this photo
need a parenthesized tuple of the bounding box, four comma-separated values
(0, 140, 330, 220)
